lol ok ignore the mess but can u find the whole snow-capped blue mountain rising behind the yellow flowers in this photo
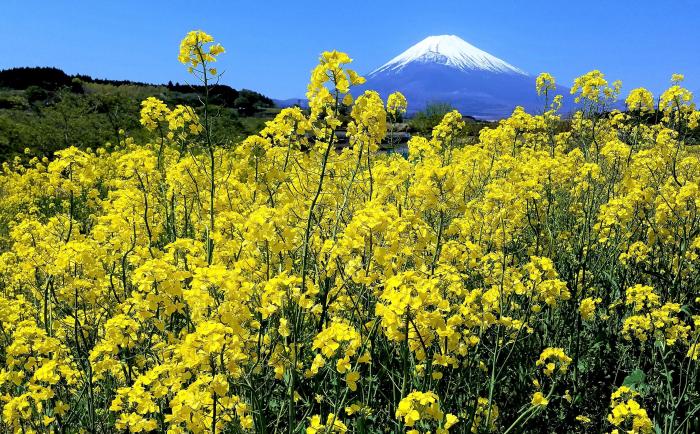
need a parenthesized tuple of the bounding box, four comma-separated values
(360, 35, 571, 120)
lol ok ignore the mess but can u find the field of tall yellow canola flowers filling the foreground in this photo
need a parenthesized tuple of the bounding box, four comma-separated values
(0, 31, 700, 434)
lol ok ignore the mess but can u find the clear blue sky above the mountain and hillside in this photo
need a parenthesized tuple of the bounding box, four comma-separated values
(0, 0, 700, 98)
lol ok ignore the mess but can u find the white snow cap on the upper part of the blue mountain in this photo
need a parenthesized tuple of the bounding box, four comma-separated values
(370, 35, 527, 76)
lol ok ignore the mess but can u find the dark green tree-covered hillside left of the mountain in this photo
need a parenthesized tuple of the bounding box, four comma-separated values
(0, 67, 277, 162)
